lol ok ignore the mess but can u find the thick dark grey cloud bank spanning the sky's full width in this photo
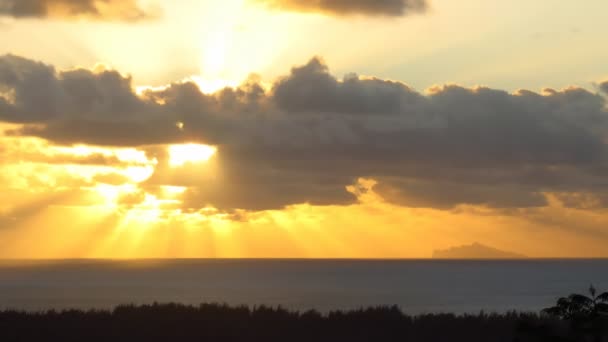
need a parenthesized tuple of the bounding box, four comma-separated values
(0, 55, 608, 209)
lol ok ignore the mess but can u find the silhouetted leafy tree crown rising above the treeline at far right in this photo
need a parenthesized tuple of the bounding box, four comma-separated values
(543, 285, 608, 320)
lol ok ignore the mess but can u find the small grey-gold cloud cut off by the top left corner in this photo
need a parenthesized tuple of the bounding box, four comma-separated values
(0, 0, 155, 21)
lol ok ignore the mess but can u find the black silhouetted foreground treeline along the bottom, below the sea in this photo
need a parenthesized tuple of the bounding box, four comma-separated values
(0, 292, 608, 342)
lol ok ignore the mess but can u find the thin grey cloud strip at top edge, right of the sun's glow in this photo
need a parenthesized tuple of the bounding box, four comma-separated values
(252, 0, 428, 17)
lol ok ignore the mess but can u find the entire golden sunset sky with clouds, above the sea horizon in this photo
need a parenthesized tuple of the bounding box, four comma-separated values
(0, 0, 608, 259)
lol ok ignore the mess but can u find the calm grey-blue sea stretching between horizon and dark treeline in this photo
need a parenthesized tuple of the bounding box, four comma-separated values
(0, 260, 608, 314)
